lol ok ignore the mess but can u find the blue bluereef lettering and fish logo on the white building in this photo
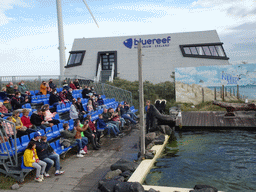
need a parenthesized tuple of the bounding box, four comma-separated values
(123, 36, 171, 49)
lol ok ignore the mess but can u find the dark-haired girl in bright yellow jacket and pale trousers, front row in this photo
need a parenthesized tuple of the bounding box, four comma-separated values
(23, 141, 46, 182)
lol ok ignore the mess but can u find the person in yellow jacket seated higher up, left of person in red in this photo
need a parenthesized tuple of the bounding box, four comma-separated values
(12, 110, 34, 138)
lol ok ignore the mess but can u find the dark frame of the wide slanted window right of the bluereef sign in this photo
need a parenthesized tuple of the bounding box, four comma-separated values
(180, 42, 229, 60)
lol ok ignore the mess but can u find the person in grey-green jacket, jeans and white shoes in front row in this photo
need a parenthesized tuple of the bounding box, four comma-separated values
(60, 123, 88, 157)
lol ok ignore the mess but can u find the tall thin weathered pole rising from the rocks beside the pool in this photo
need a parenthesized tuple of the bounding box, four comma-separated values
(138, 43, 145, 157)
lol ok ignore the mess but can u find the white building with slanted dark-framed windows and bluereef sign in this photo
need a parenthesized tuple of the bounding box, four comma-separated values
(65, 30, 229, 83)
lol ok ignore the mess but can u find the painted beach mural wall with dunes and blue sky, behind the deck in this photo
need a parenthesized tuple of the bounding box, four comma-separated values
(175, 64, 256, 104)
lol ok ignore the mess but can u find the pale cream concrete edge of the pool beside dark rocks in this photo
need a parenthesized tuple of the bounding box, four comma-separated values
(128, 135, 193, 192)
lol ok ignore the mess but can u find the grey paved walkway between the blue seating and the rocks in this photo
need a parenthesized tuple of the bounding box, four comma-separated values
(2, 129, 139, 192)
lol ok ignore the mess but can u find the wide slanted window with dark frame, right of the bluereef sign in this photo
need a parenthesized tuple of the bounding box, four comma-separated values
(180, 43, 229, 60)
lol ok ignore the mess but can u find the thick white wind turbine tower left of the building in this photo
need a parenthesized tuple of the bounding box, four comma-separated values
(56, 0, 66, 80)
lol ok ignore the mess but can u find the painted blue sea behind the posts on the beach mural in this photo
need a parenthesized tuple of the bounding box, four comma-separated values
(209, 85, 256, 100)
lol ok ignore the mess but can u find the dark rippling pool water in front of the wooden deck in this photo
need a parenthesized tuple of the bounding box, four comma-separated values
(144, 130, 256, 192)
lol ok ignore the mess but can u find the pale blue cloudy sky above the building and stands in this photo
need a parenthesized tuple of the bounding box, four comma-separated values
(0, 0, 256, 76)
